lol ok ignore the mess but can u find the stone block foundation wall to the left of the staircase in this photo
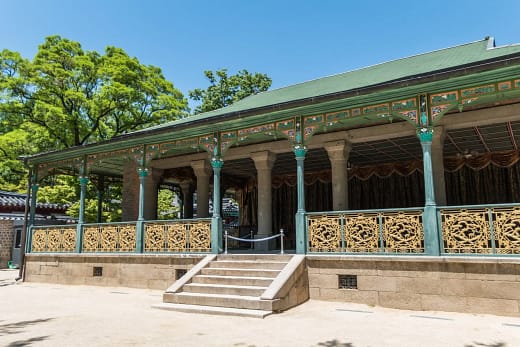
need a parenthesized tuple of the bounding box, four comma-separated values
(25, 254, 204, 290)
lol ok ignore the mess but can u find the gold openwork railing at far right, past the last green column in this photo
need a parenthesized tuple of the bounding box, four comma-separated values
(439, 206, 520, 254)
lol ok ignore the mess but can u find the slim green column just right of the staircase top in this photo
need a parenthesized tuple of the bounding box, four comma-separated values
(294, 145, 307, 254)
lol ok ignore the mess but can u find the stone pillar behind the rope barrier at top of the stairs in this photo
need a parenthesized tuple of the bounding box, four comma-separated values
(251, 151, 276, 251)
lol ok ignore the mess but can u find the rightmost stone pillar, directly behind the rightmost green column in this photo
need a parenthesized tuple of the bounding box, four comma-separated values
(432, 126, 447, 206)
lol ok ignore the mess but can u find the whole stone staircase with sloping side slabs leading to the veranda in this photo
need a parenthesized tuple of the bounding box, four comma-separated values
(154, 254, 309, 318)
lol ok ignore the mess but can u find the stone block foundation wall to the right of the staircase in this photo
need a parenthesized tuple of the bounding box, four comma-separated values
(307, 255, 520, 316)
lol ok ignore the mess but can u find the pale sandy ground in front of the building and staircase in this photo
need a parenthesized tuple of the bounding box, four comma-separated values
(0, 270, 520, 347)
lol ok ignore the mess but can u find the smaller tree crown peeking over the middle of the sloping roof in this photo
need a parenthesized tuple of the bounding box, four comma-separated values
(189, 69, 272, 113)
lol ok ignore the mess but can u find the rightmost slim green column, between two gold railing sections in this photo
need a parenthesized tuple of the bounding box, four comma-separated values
(419, 129, 440, 255)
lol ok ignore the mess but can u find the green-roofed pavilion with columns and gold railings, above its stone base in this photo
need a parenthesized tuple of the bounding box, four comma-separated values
(25, 39, 520, 256)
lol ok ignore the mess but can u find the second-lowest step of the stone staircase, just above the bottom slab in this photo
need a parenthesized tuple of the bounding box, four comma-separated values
(167, 292, 278, 311)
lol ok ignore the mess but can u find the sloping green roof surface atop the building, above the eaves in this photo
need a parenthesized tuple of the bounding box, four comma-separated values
(142, 37, 520, 131)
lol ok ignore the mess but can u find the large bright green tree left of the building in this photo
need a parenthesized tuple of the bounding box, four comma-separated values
(0, 36, 187, 149)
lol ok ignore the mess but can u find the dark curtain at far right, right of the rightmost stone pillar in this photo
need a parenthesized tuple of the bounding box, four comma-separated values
(444, 162, 520, 205)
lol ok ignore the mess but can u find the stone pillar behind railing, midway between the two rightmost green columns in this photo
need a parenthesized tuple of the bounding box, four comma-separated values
(324, 140, 352, 211)
